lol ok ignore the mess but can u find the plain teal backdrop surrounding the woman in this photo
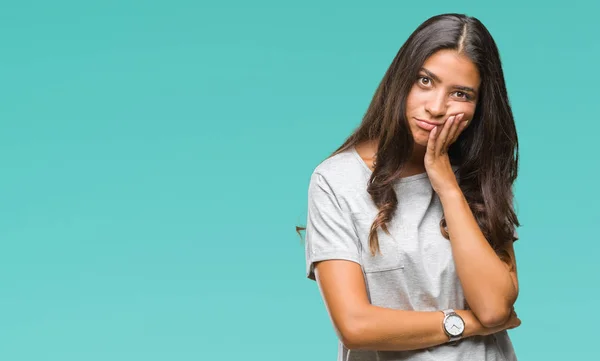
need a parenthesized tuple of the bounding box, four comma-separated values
(0, 0, 600, 361)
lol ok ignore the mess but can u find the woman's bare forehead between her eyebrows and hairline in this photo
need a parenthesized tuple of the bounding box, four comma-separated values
(423, 49, 481, 89)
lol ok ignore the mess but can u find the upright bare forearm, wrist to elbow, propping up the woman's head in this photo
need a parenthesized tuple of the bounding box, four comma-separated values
(440, 190, 517, 327)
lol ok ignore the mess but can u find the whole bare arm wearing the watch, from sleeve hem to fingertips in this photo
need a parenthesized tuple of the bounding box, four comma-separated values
(315, 260, 520, 351)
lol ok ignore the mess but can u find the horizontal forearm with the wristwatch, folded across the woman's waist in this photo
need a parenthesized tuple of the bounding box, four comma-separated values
(341, 305, 483, 351)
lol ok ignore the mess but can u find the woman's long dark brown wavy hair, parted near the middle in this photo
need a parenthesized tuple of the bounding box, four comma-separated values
(296, 14, 520, 258)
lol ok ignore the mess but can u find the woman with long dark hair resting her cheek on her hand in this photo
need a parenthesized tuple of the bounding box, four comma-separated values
(301, 14, 521, 361)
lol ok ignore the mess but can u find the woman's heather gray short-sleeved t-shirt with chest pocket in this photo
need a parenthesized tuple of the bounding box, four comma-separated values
(305, 147, 516, 361)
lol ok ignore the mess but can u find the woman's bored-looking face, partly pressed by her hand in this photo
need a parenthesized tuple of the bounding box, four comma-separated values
(406, 50, 481, 146)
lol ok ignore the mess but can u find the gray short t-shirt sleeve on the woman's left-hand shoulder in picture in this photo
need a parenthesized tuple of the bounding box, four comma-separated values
(305, 172, 360, 280)
